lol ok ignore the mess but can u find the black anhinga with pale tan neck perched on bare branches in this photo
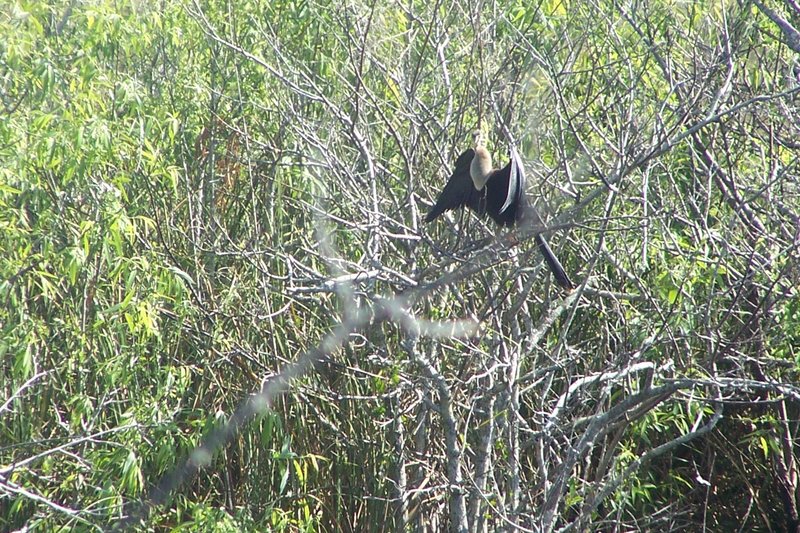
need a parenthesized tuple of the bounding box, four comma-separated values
(425, 132, 573, 289)
